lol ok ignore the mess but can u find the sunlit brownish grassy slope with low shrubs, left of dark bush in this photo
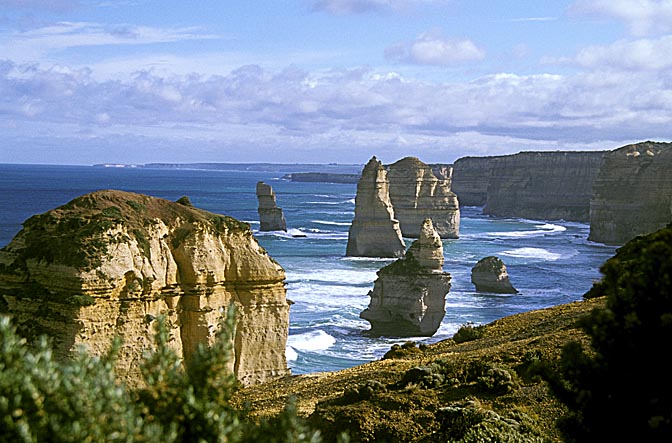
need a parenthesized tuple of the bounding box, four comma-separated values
(234, 298, 604, 441)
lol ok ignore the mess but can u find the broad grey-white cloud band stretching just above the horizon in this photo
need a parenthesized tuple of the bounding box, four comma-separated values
(0, 56, 672, 165)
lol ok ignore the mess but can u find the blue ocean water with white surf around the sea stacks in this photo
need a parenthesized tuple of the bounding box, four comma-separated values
(0, 164, 615, 374)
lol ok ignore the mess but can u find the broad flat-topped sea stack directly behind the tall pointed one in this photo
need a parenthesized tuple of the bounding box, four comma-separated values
(387, 157, 460, 238)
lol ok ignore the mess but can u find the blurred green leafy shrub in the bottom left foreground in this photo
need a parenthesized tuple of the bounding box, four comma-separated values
(0, 309, 320, 443)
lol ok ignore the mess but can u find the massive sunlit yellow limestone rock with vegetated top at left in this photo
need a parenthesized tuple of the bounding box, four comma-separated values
(0, 191, 289, 384)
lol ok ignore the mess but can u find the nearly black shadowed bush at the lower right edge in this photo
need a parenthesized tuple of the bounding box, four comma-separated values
(546, 226, 672, 442)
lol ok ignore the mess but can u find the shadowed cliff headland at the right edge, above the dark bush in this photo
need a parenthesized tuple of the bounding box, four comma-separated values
(588, 141, 672, 245)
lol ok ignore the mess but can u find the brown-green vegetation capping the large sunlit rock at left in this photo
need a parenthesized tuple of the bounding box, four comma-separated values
(6, 190, 251, 269)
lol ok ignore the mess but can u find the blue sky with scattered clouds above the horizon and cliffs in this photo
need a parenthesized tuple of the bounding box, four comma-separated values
(0, 0, 672, 164)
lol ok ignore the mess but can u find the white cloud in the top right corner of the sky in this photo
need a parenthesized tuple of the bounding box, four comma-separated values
(569, 0, 672, 36)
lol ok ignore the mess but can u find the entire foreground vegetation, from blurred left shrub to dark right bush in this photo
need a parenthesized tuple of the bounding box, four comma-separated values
(0, 198, 672, 443)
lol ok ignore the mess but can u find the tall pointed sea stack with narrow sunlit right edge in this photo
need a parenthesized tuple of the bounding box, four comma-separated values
(345, 157, 405, 257)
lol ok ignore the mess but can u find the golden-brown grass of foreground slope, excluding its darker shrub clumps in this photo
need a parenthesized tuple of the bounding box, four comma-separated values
(235, 298, 604, 441)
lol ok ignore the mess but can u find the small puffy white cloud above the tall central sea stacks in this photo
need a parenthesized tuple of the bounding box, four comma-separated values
(385, 33, 485, 66)
